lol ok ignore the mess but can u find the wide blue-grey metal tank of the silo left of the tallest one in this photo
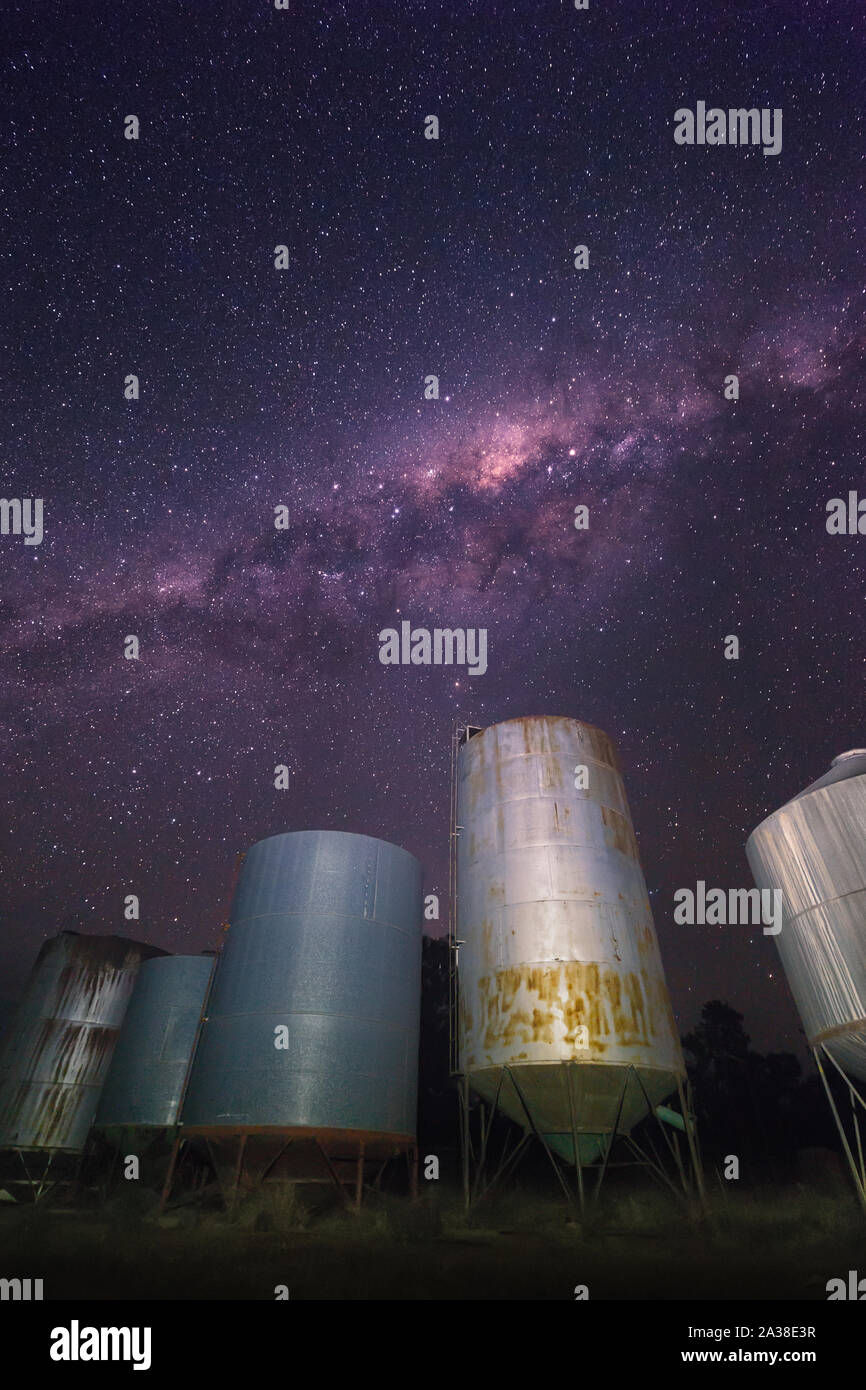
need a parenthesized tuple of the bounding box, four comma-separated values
(182, 831, 423, 1136)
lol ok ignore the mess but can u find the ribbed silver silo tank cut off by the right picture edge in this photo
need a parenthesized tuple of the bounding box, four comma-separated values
(746, 749, 866, 1080)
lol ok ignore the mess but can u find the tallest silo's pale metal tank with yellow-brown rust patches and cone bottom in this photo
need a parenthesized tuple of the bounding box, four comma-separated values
(457, 717, 685, 1162)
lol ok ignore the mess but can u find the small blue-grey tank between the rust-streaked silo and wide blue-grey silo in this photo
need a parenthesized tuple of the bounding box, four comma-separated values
(93, 955, 214, 1129)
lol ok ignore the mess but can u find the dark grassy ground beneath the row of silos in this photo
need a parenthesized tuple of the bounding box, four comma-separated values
(0, 1183, 866, 1301)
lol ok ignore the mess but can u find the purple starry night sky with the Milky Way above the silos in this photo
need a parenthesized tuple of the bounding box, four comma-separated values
(0, 0, 866, 1049)
